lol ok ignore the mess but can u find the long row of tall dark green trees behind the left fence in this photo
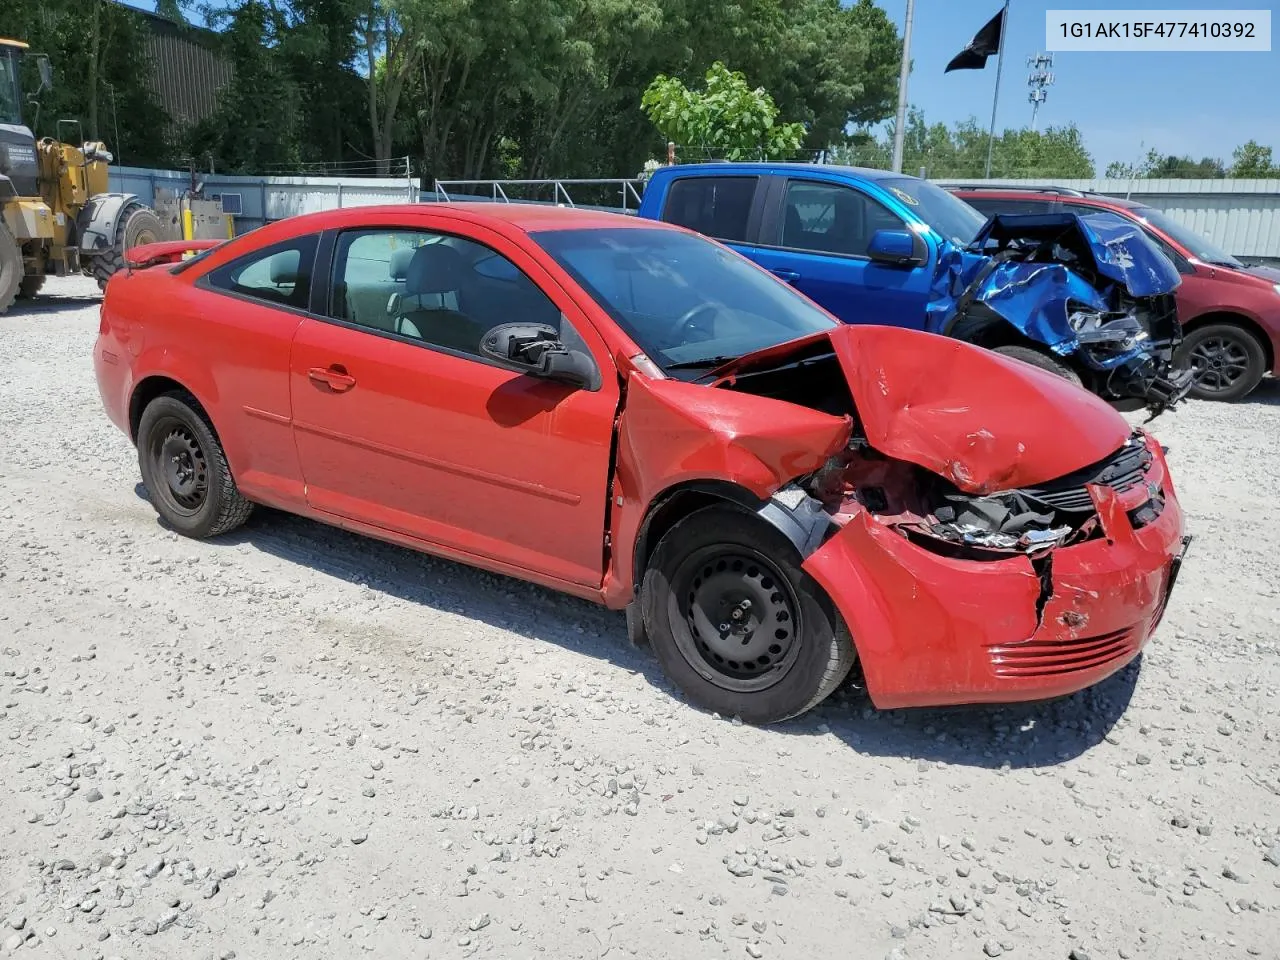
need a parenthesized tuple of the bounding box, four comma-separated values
(5, 0, 901, 179)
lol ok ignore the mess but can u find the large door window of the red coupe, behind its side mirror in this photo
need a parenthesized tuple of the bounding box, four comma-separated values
(329, 228, 561, 356)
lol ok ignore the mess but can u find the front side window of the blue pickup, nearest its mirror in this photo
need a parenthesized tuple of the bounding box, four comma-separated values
(782, 180, 906, 256)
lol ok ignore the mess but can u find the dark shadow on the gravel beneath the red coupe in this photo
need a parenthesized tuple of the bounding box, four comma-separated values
(134, 483, 1140, 769)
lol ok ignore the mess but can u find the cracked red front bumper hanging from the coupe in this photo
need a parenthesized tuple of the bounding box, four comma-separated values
(804, 448, 1185, 708)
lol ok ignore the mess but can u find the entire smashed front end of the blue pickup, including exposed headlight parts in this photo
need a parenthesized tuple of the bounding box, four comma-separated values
(927, 214, 1194, 417)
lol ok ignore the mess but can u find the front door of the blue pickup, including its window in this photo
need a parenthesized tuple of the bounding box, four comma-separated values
(751, 177, 932, 329)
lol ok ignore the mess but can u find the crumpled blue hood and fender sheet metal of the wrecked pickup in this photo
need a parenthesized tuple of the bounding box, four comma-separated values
(925, 214, 1181, 369)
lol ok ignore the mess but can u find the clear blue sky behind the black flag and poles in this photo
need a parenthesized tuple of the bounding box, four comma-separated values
(125, 0, 1280, 168)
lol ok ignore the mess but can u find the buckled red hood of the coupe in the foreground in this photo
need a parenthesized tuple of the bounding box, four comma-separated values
(713, 324, 1130, 494)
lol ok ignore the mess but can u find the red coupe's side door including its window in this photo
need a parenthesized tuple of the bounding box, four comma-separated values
(291, 221, 618, 586)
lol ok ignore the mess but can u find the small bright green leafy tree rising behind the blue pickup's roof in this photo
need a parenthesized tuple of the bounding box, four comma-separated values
(640, 60, 805, 160)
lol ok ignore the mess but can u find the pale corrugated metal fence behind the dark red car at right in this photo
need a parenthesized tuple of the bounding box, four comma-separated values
(942, 178, 1280, 260)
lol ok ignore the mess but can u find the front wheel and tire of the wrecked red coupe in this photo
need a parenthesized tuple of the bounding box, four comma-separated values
(640, 506, 858, 723)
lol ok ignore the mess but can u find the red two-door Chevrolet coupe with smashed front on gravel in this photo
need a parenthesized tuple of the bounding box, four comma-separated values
(93, 204, 1187, 723)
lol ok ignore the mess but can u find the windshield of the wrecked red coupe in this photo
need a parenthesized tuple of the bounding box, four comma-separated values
(532, 227, 837, 379)
